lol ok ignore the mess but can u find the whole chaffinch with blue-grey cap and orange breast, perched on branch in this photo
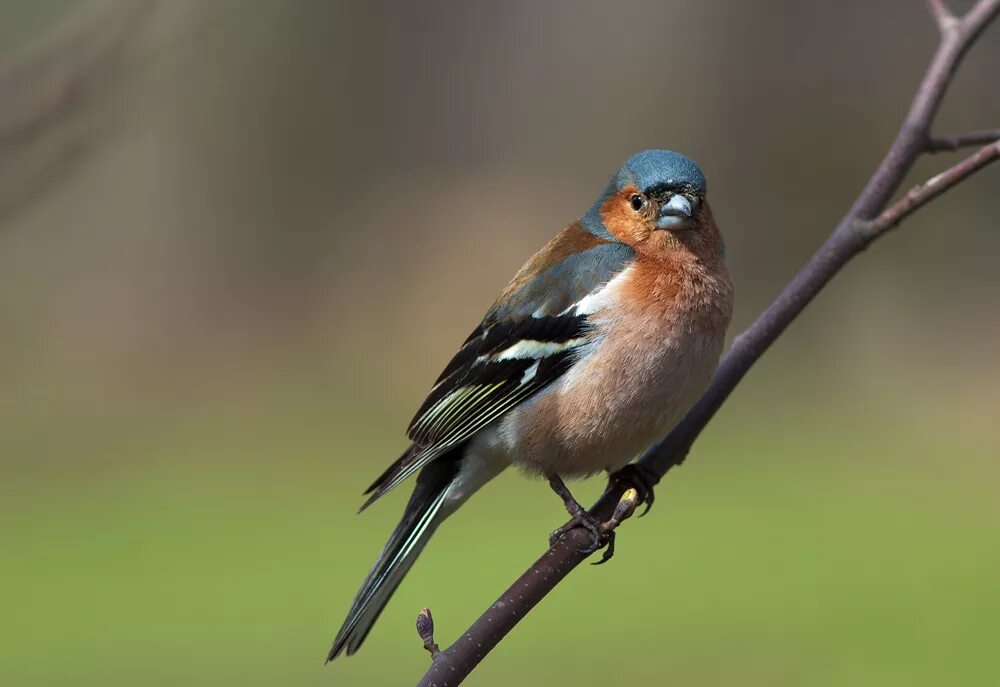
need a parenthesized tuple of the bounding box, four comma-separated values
(327, 150, 734, 662)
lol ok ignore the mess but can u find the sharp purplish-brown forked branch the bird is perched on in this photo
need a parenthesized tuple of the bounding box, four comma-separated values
(418, 0, 1000, 687)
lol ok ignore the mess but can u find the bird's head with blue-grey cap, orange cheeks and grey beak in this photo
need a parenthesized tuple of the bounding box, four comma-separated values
(582, 150, 722, 259)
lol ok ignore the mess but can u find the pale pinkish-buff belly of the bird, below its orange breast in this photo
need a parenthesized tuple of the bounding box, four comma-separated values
(498, 322, 723, 477)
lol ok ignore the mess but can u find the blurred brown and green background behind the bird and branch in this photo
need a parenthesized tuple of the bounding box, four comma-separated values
(0, 0, 1000, 687)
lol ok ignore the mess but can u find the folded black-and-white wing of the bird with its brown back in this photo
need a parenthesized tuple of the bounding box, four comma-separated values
(362, 224, 634, 509)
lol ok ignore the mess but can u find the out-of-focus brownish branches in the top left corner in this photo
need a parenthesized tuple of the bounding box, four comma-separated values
(0, 0, 240, 223)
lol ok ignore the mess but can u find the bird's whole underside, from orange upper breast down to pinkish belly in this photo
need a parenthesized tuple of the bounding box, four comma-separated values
(499, 253, 732, 477)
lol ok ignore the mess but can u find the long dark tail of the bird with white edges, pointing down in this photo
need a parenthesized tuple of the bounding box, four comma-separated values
(326, 448, 478, 662)
